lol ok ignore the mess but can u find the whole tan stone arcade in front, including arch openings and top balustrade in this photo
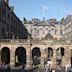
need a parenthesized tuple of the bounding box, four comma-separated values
(0, 38, 72, 68)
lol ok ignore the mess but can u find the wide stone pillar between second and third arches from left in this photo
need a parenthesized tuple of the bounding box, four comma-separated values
(26, 48, 32, 69)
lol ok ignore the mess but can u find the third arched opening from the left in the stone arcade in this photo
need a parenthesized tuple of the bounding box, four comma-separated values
(32, 47, 41, 66)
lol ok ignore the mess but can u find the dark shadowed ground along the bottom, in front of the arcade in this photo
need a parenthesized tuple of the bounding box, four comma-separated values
(0, 67, 68, 72)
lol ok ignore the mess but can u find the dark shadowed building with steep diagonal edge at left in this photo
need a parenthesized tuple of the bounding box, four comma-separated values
(0, 0, 28, 39)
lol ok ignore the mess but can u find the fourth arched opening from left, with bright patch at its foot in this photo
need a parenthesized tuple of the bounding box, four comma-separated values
(44, 47, 53, 65)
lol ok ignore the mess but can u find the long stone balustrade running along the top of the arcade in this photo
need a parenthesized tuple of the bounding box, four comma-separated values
(0, 39, 70, 44)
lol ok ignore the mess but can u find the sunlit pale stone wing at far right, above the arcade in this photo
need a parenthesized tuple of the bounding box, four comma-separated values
(63, 15, 72, 40)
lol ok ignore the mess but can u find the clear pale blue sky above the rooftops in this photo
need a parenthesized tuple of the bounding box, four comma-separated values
(9, 0, 72, 20)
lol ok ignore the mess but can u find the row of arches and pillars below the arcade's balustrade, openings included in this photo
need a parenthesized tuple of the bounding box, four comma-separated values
(0, 45, 72, 68)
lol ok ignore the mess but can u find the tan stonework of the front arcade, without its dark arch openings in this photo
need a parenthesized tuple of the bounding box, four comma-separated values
(0, 39, 72, 68)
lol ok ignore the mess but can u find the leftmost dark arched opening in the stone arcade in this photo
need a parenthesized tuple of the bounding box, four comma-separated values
(1, 47, 10, 64)
